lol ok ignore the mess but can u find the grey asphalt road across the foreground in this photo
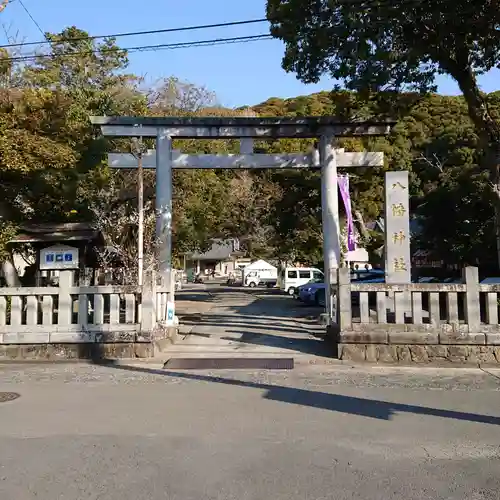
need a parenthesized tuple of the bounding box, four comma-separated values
(0, 364, 500, 500)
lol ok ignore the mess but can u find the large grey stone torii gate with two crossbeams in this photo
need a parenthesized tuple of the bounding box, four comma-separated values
(91, 116, 394, 319)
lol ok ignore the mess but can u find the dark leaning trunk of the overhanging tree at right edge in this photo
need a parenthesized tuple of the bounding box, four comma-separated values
(456, 67, 500, 269)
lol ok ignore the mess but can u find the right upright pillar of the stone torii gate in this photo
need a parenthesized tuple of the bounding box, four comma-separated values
(319, 136, 341, 323)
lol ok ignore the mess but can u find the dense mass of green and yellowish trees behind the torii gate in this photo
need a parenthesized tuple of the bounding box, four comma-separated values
(0, 24, 500, 282)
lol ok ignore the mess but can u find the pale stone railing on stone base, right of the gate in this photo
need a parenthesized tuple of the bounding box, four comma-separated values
(329, 267, 500, 363)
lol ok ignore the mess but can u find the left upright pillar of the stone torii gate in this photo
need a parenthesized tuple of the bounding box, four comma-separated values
(156, 129, 174, 303)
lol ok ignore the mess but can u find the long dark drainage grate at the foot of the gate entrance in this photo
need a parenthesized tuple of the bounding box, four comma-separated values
(163, 358, 294, 370)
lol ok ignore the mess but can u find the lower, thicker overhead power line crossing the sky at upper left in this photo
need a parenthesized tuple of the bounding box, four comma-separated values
(4, 33, 273, 62)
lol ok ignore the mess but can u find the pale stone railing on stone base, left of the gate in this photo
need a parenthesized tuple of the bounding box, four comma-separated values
(0, 271, 175, 359)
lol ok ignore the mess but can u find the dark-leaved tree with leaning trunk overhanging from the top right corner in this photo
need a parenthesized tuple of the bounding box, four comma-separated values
(267, 0, 500, 265)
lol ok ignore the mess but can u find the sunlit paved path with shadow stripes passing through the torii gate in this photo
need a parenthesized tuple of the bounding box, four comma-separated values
(170, 285, 334, 362)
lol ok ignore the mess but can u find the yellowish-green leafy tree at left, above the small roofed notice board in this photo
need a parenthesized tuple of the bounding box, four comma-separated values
(0, 28, 146, 282)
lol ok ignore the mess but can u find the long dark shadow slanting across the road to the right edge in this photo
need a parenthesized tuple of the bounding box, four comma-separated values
(96, 362, 500, 425)
